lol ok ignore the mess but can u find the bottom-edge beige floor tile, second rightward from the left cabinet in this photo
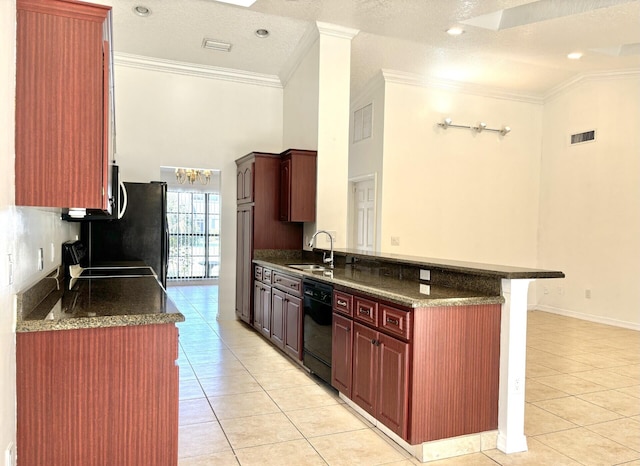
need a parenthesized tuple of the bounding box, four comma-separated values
(236, 439, 327, 466)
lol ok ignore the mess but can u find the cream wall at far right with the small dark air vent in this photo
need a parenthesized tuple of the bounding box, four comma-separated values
(538, 73, 640, 329)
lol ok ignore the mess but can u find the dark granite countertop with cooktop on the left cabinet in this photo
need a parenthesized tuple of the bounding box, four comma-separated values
(16, 273, 185, 332)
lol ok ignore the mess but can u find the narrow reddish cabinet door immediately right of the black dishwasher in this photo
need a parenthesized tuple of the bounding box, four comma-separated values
(331, 312, 353, 398)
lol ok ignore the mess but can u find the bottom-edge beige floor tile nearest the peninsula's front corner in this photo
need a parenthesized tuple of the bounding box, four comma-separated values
(309, 429, 409, 466)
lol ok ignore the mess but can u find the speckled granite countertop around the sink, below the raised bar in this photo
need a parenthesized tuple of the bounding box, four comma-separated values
(253, 256, 504, 308)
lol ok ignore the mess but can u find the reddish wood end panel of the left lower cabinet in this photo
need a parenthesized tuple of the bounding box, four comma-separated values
(16, 324, 178, 466)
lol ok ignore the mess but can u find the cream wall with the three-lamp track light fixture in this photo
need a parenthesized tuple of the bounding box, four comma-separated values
(381, 79, 542, 267)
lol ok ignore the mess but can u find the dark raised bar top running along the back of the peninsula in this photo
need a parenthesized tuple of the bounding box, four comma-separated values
(314, 248, 565, 280)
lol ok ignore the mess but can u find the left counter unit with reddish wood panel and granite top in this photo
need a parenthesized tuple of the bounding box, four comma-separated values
(16, 271, 184, 466)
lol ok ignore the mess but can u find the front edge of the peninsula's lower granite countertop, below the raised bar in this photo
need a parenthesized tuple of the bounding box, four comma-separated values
(253, 259, 504, 308)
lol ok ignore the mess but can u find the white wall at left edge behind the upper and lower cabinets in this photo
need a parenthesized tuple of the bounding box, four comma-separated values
(0, 0, 78, 452)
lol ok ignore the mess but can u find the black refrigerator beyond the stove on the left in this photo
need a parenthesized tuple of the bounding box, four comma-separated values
(81, 181, 169, 288)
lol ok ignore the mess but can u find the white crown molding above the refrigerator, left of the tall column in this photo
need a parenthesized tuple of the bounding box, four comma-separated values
(114, 52, 282, 89)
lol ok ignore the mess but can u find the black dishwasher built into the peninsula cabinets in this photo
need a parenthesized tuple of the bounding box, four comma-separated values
(302, 279, 333, 384)
